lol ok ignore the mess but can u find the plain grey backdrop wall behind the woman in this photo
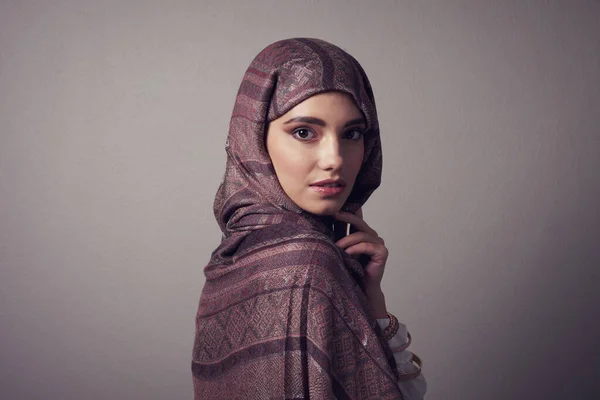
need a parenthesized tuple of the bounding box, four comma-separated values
(0, 0, 600, 400)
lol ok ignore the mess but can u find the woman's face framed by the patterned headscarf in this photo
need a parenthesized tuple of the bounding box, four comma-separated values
(267, 92, 366, 215)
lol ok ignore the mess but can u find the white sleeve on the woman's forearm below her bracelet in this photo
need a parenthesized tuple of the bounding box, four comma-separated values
(377, 318, 427, 400)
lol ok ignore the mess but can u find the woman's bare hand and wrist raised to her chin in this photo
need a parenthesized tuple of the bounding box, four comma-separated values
(334, 208, 388, 318)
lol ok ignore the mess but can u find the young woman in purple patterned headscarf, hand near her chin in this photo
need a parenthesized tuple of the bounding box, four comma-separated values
(192, 39, 426, 400)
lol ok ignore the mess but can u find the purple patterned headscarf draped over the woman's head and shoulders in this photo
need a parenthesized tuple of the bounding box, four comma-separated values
(192, 38, 401, 399)
